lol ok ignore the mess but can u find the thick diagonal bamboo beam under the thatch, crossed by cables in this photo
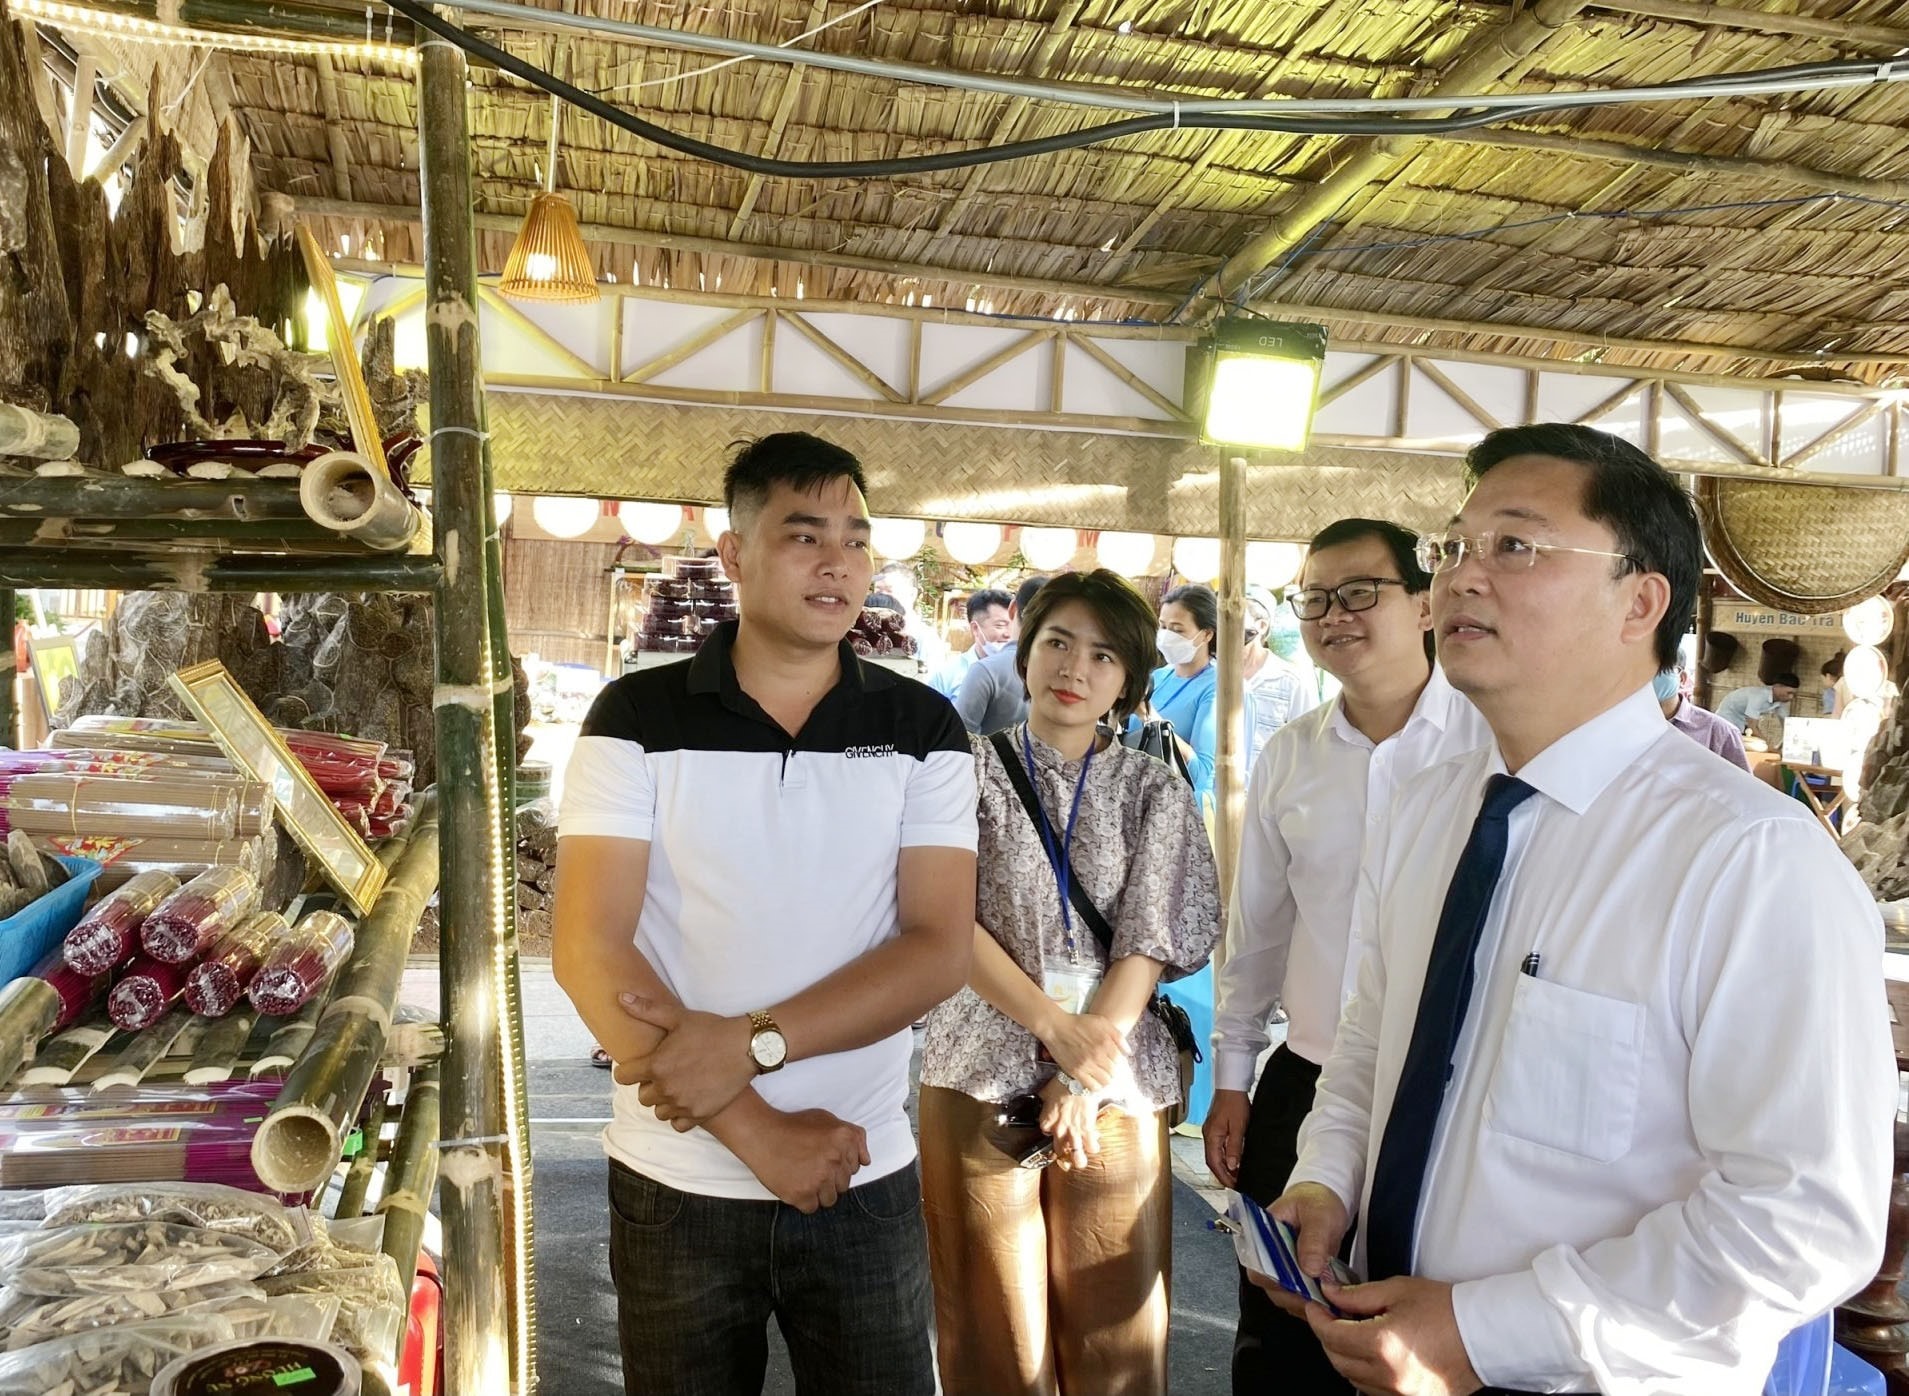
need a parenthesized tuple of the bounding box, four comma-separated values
(1212, 0, 1588, 309)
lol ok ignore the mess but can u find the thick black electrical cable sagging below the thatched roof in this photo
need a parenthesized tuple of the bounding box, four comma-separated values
(386, 0, 1909, 180)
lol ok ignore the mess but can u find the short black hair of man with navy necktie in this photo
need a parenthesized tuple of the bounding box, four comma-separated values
(1464, 422, 1703, 668)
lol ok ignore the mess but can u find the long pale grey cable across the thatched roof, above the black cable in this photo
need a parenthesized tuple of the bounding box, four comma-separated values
(425, 0, 1909, 118)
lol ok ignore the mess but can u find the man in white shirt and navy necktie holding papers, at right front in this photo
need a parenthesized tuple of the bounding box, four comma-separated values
(1271, 426, 1896, 1396)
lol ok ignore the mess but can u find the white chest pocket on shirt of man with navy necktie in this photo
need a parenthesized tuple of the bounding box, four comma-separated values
(1485, 974, 1644, 1163)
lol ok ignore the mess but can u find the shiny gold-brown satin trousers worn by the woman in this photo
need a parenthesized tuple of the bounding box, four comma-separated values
(920, 1087, 1172, 1396)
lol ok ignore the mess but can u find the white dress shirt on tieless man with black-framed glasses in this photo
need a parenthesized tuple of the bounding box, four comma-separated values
(1212, 666, 1491, 1090)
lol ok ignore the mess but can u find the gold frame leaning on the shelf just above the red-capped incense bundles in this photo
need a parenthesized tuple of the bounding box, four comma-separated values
(168, 659, 384, 917)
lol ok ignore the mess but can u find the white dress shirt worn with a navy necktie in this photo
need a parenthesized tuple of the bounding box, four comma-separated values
(1292, 687, 1896, 1396)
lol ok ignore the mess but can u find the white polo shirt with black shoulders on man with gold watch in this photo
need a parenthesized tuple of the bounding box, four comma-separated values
(557, 623, 975, 1197)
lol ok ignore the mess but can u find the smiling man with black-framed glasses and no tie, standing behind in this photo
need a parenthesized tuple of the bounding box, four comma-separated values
(1205, 519, 1491, 1396)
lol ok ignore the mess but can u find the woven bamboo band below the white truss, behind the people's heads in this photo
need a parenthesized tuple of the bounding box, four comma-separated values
(442, 391, 1462, 539)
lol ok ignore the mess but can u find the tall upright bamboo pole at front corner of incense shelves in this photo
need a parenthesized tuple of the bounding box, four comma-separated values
(418, 32, 519, 1394)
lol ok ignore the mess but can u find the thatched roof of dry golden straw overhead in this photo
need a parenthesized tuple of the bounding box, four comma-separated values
(33, 0, 1909, 382)
